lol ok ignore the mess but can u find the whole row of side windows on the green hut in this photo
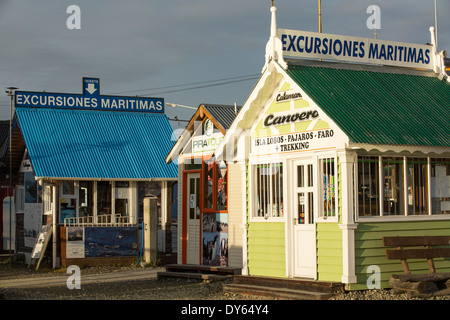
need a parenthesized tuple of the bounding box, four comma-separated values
(357, 156, 450, 217)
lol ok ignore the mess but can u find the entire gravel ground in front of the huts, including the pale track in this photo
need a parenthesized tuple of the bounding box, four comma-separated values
(0, 262, 450, 300)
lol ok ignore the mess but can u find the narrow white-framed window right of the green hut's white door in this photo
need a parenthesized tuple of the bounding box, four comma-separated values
(319, 158, 337, 219)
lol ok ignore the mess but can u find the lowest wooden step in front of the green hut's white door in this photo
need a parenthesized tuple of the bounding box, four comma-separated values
(223, 283, 335, 300)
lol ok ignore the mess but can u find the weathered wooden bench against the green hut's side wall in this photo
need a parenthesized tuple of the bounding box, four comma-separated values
(383, 236, 450, 294)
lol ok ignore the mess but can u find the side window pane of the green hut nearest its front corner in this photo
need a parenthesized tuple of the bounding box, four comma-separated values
(358, 157, 380, 216)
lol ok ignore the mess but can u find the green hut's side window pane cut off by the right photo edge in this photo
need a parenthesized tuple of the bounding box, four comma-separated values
(430, 159, 450, 214)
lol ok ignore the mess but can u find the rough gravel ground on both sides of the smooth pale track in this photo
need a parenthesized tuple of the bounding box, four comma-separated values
(0, 262, 450, 300)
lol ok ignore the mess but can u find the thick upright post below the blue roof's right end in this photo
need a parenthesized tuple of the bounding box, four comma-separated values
(142, 197, 158, 263)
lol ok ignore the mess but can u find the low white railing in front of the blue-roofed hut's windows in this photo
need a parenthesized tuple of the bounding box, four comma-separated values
(64, 214, 134, 227)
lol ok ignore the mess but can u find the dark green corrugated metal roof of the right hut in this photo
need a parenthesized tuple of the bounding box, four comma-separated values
(287, 65, 450, 147)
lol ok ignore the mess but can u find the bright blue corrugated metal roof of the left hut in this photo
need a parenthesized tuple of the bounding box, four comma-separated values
(16, 108, 178, 180)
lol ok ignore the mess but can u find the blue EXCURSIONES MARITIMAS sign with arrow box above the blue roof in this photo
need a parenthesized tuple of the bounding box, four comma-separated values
(15, 78, 164, 113)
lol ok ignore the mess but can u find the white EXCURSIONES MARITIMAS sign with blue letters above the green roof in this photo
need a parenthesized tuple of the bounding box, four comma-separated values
(277, 29, 433, 69)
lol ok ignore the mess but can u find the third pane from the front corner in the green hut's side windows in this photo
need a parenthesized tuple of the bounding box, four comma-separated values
(407, 158, 428, 215)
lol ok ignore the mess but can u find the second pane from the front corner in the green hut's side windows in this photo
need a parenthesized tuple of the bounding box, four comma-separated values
(383, 158, 404, 215)
